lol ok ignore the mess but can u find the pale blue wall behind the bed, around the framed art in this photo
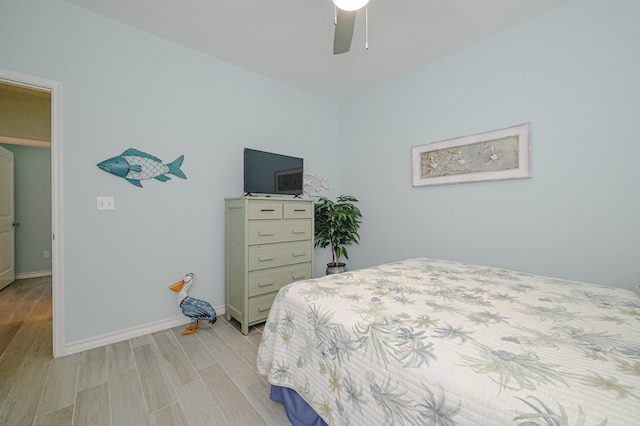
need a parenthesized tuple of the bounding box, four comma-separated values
(340, 0, 640, 288)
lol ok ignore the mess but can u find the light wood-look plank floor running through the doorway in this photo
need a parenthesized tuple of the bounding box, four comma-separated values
(0, 277, 290, 426)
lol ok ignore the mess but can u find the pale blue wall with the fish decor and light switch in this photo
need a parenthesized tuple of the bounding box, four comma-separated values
(0, 0, 337, 343)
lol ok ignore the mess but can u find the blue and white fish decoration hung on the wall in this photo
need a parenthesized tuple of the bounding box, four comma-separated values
(98, 148, 187, 188)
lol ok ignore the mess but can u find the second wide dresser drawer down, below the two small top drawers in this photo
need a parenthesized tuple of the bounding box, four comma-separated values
(249, 241, 313, 271)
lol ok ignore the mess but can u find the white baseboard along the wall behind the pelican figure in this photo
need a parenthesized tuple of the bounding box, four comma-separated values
(64, 306, 225, 355)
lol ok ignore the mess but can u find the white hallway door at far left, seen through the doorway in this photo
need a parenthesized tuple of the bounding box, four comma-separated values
(0, 146, 16, 289)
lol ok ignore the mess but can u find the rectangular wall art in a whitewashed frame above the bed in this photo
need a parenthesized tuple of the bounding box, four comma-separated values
(411, 123, 531, 186)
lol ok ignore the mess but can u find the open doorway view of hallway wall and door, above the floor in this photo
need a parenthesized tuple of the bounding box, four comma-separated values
(0, 82, 52, 287)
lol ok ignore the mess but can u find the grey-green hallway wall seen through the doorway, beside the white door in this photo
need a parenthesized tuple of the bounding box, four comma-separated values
(0, 144, 51, 275)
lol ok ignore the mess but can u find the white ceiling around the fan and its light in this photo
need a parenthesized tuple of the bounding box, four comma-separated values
(67, 0, 569, 101)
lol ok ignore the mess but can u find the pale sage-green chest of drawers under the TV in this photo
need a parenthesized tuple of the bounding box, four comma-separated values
(225, 197, 314, 334)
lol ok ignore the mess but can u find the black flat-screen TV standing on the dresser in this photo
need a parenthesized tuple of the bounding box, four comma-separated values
(244, 148, 303, 195)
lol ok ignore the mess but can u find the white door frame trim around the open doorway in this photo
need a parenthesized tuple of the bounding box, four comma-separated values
(0, 68, 66, 358)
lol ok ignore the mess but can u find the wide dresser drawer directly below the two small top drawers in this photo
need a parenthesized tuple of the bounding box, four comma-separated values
(247, 219, 313, 245)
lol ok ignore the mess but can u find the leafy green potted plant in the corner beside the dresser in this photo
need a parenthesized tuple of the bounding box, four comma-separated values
(315, 195, 362, 274)
